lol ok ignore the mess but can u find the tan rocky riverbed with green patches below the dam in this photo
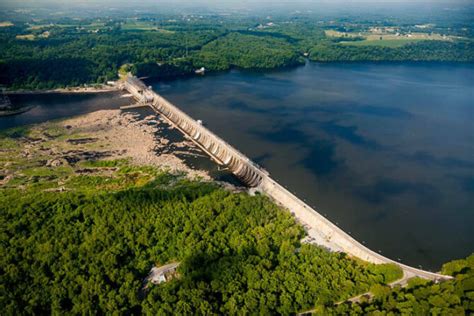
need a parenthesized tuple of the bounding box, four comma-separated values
(0, 110, 211, 191)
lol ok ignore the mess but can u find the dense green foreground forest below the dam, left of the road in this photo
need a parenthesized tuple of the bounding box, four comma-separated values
(0, 182, 399, 314)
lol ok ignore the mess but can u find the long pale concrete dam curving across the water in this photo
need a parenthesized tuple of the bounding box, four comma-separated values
(119, 75, 451, 283)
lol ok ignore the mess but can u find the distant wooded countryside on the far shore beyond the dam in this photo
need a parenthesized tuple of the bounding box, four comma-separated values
(0, 15, 474, 89)
